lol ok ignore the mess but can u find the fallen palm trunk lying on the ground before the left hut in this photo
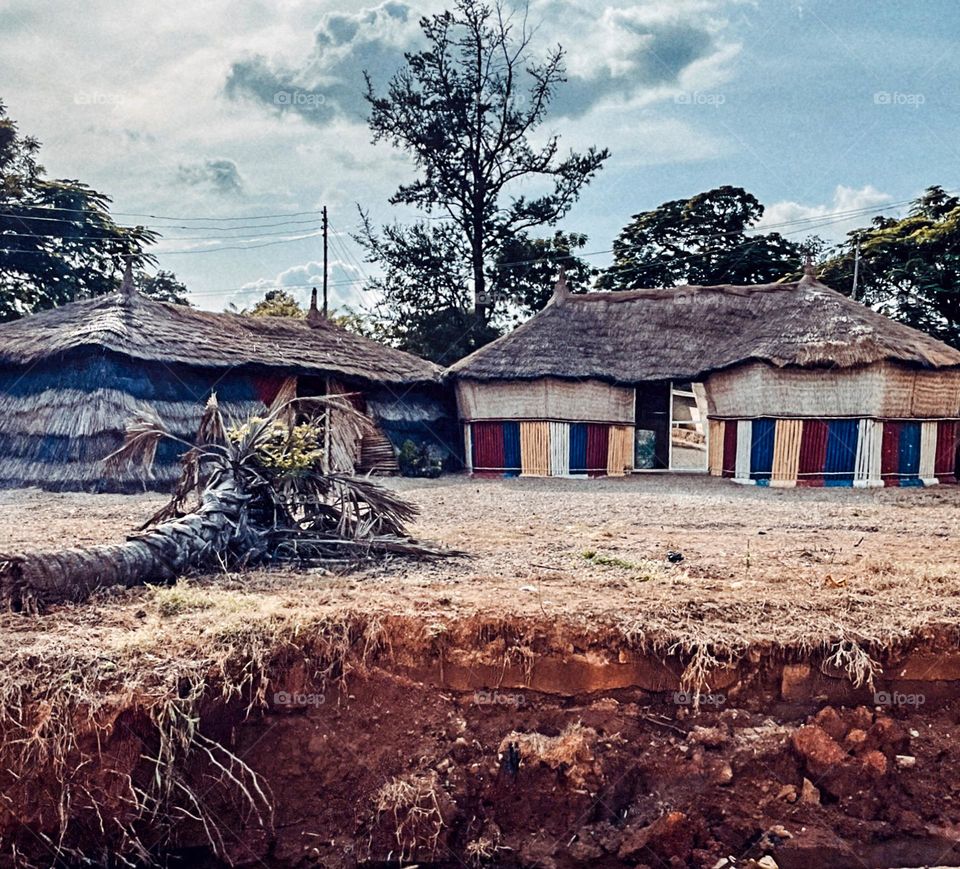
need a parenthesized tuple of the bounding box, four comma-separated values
(0, 476, 256, 612)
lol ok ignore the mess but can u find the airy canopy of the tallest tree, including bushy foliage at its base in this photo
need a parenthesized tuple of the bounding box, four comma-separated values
(358, 0, 608, 361)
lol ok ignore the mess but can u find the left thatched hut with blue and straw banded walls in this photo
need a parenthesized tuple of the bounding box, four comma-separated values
(0, 281, 459, 491)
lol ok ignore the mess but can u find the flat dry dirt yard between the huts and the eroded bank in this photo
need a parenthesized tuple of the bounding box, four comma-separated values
(0, 475, 960, 646)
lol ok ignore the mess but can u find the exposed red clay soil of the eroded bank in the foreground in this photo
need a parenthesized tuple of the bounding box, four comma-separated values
(9, 652, 960, 869)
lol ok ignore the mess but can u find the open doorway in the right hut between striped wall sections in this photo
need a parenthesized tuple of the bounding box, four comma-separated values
(634, 381, 708, 473)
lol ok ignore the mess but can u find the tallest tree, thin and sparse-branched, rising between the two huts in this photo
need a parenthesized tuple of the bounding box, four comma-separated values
(366, 0, 608, 342)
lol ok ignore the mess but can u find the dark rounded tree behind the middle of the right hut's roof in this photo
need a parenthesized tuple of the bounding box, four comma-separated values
(598, 186, 804, 290)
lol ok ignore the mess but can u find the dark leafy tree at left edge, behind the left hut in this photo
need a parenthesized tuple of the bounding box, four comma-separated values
(0, 103, 157, 321)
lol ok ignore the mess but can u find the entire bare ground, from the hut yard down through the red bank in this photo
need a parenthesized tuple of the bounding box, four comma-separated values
(0, 476, 960, 869)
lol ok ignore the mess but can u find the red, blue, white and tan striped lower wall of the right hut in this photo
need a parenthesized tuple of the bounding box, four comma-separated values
(463, 417, 960, 487)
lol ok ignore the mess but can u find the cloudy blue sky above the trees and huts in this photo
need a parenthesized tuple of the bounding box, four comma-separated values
(0, 0, 960, 310)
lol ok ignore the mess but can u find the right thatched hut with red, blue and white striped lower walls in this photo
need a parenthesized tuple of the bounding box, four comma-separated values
(450, 267, 960, 487)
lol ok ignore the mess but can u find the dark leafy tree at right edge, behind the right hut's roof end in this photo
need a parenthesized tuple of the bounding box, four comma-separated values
(820, 186, 960, 347)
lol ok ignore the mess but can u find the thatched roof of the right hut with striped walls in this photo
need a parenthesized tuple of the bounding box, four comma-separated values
(450, 274, 960, 383)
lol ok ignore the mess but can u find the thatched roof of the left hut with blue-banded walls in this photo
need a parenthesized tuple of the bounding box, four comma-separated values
(0, 292, 441, 383)
